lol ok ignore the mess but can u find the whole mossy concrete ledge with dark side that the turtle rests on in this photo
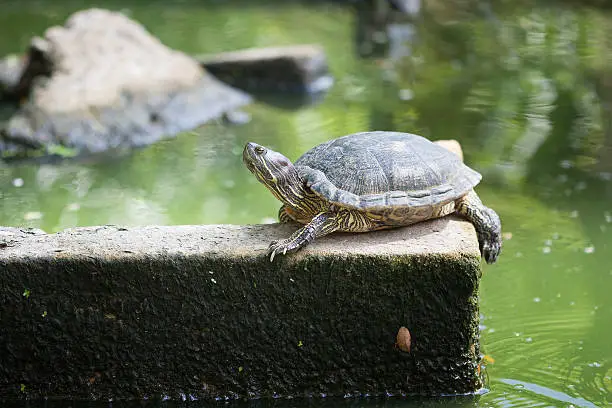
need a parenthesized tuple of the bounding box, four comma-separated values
(0, 220, 481, 400)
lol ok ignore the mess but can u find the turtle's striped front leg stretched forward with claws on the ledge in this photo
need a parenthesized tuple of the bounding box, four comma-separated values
(268, 212, 339, 262)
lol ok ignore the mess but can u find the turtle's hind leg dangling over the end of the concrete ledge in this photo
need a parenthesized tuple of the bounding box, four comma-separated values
(455, 190, 502, 264)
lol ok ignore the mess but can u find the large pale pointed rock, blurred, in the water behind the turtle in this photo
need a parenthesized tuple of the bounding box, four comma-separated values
(0, 9, 251, 153)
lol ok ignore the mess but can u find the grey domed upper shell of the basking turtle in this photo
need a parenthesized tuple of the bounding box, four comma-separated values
(295, 131, 482, 210)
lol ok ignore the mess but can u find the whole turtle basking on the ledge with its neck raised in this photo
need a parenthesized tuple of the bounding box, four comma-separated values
(242, 131, 502, 264)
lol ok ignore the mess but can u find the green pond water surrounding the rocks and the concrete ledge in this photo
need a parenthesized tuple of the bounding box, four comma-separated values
(0, 0, 612, 407)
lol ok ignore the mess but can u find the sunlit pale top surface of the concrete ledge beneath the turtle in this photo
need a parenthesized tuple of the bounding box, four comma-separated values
(0, 216, 480, 262)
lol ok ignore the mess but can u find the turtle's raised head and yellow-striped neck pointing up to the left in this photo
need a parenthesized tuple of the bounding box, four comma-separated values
(242, 142, 304, 208)
